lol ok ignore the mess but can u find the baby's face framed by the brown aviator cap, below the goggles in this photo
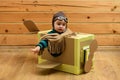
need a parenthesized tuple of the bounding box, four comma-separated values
(54, 20, 67, 33)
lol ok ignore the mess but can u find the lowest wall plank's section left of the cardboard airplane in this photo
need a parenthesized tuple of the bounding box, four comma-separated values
(0, 34, 38, 45)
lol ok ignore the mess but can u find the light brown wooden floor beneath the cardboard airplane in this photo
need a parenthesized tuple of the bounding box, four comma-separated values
(0, 46, 120, 80)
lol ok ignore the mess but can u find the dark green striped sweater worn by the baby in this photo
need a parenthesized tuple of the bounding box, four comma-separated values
(36, 29, 62, 49)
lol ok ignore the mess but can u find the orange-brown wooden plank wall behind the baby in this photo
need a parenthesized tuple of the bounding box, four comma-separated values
(0, 0, 120, 46)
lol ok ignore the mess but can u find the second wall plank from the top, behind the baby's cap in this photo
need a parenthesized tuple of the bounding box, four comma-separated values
(0, 12, 120, 23)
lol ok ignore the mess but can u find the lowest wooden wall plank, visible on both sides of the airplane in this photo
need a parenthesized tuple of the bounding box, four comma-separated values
(0, 34, 120, 46)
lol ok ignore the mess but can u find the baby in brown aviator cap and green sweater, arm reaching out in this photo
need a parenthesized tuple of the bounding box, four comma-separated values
(32, 11, 70, 56)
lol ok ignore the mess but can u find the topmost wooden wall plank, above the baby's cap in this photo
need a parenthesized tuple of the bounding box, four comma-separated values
(0, 0, 120, 12)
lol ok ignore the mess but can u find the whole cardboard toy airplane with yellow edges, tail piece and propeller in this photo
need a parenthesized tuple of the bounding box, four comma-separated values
(23, 20, 97, 74)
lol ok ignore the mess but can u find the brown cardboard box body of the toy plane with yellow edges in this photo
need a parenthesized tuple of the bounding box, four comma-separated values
(38, 30, 94, 74)
